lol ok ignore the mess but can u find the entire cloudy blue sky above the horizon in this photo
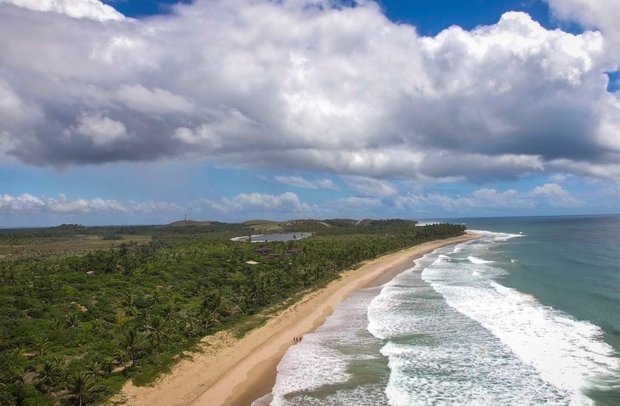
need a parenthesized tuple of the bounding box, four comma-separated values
(0, 0, 620, 228)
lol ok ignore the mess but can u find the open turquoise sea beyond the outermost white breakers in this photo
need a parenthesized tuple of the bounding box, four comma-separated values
(468, 216, 620, 352)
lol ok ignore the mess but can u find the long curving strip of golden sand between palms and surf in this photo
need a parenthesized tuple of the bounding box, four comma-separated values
(114, 234, 477, 406)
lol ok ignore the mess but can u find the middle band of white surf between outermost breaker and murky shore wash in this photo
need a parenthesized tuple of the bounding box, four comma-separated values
(368, 246, 567, 406)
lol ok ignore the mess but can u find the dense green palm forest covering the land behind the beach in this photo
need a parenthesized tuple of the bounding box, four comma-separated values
(0, 219, 465, 405)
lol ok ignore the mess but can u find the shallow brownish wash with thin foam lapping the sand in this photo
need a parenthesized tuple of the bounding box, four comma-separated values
(271, 288, 388, 406)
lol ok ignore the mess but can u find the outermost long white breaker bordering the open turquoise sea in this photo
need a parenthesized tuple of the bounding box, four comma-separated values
(422, 233, 620, 404)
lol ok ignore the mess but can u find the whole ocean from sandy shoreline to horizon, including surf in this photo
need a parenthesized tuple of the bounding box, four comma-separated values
(255, 216, 620, 406)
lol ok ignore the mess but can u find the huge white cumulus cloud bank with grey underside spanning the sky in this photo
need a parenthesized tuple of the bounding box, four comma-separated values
(0, 0, 620, 181)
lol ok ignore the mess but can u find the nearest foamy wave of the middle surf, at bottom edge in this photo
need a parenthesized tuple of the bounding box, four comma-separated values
(382, 337, 567, 406)
